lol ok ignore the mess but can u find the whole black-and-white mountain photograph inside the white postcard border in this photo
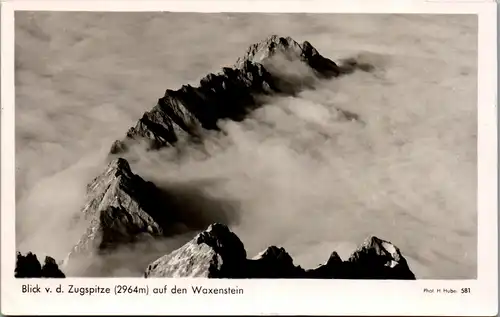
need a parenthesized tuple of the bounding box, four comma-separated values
(12, 11, 478, 280)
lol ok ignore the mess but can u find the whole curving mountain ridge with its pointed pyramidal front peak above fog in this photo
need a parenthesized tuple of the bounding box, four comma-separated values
(68, 35, 372, 259)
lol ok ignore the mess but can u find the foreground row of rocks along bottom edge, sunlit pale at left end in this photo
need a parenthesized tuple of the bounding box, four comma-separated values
(144, 224, 415, 280)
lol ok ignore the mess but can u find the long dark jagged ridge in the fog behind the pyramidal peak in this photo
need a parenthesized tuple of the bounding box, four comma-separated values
(110, 35, 342, 154)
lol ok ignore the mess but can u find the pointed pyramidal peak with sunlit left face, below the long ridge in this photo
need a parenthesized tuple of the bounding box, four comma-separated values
(65, 158, 174, 258)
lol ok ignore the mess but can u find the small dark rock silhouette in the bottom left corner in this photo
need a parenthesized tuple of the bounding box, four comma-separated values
(14, 252, 66, 278)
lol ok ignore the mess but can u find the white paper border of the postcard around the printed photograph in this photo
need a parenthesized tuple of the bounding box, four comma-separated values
(0, 0, 498, 316)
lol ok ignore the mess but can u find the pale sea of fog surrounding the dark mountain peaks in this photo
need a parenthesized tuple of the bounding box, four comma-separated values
(15, 12, 477, 279)
